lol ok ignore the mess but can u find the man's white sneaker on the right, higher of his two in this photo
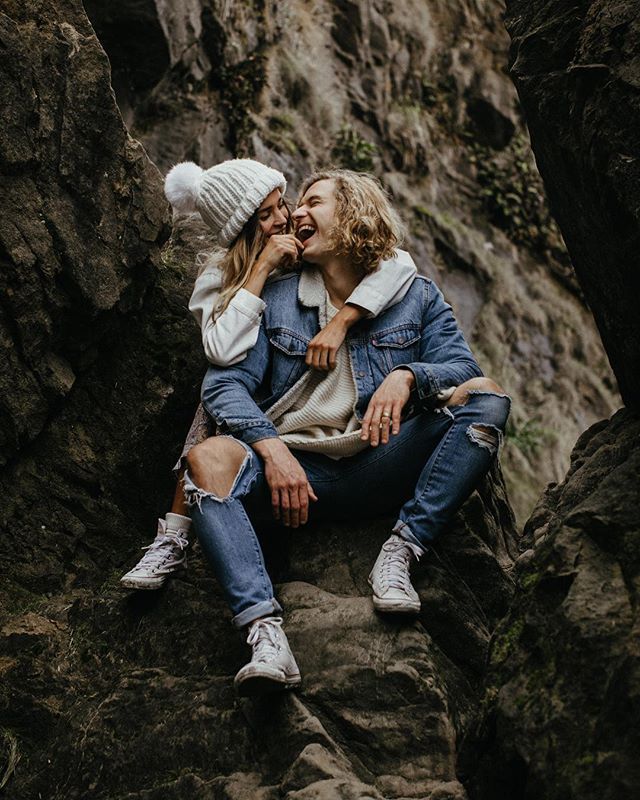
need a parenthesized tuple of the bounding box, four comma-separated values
(369, 533, 423, 614)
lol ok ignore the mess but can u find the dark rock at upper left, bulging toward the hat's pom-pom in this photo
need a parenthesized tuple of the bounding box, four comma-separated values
(0, 2, 166, 464)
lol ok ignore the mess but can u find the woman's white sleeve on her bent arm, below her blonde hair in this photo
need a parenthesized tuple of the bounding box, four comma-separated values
(189, 267, 265, 367)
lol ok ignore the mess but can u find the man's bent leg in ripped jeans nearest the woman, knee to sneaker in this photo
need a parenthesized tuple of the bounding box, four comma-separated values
(185, 436, 300, 695)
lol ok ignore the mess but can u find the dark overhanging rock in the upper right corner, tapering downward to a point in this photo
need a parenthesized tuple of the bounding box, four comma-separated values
(506, 0, 640, 409)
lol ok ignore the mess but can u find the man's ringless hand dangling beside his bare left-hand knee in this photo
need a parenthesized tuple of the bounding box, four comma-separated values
(252, 438, 318, 528)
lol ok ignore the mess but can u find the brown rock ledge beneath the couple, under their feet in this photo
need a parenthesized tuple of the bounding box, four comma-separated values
(0, 466, 516, 800)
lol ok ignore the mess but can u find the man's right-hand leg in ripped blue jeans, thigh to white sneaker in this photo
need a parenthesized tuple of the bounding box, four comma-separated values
(296, 378, 510, 612)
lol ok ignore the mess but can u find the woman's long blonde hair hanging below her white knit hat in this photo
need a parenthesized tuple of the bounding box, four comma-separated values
(196, 198, 291, 317)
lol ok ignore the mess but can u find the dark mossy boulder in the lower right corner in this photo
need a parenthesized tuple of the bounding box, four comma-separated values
(463, 410, 640, 800)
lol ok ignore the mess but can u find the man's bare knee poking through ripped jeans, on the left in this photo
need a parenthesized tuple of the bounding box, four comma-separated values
(187, 436, 247, 497)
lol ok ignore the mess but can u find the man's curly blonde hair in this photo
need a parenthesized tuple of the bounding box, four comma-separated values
(299, 169, 404, 272)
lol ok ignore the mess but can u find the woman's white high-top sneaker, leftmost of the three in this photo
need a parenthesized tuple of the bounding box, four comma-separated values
(120, 514, 191, 589)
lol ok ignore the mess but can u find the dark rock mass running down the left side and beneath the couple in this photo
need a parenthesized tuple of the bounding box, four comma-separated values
(0, 0, 516, 800)
